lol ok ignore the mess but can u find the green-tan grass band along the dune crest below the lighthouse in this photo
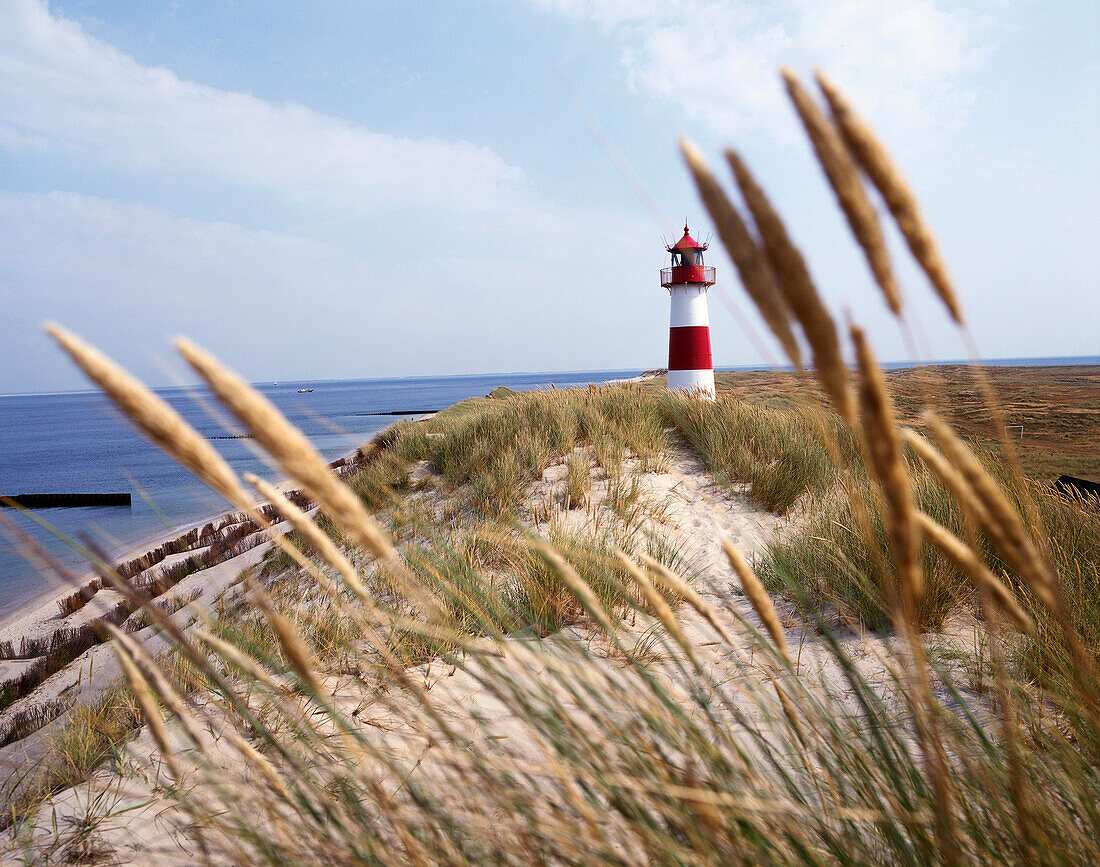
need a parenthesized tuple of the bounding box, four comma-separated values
(325, 376, 1100, 647)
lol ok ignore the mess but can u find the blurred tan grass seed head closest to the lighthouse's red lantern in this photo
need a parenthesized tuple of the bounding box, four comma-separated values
(680, 139, 802, 370)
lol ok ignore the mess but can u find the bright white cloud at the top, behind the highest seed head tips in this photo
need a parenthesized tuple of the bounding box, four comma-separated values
(534, 0, 988, 135)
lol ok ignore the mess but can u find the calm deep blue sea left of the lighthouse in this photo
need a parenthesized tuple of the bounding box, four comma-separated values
(0, 371, 637, 617)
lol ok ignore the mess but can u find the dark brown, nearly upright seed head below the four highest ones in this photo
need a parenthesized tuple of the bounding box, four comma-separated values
(851, 326, 924, 621)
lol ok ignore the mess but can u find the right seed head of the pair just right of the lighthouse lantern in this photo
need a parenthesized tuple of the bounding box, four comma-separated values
(726, 151, 855, 422)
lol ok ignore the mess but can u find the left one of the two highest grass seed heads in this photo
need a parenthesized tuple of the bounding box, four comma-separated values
(783, 69, 902, 316)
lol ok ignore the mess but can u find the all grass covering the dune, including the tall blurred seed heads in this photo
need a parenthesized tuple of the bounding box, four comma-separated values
(2, 69, 1100, 864)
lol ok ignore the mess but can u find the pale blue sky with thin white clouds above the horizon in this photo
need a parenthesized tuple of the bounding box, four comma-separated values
(0, 0, 1100, 393)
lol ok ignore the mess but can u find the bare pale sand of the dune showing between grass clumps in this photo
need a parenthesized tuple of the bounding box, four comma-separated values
(0, 449, 994, 865)
